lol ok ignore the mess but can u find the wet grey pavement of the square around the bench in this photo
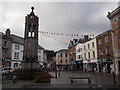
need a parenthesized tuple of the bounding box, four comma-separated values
(2, 71, 120, 90)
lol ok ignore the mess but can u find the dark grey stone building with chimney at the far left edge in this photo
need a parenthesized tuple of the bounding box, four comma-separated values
(2, 29, 12, 67)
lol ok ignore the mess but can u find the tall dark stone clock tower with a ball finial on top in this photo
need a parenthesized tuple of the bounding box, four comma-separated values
(21, 7, 39, 69)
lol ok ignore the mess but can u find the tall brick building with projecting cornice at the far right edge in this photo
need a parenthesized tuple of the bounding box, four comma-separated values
(107, 5, 120, 75)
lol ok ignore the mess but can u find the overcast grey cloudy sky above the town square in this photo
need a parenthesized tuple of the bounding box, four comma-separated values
(0, 2, 118, 50)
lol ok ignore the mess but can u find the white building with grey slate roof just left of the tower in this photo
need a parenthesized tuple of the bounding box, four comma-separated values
(11, 34, 24, 69)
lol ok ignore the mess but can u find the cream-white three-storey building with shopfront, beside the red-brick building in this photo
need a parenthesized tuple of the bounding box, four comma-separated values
(83, 38, 98, 71)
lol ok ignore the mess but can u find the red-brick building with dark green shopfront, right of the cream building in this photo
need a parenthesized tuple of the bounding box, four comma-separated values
(96, 30, 114, 73)
